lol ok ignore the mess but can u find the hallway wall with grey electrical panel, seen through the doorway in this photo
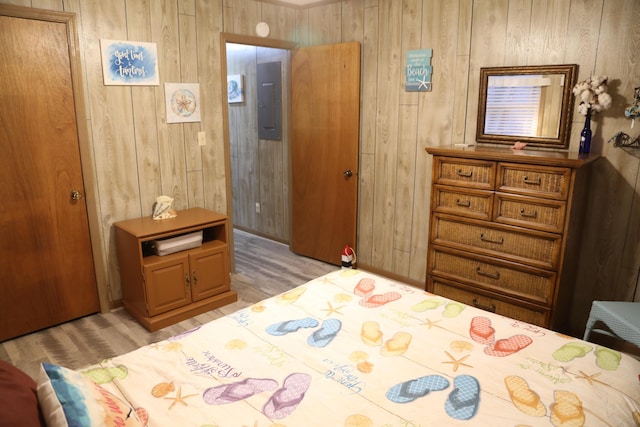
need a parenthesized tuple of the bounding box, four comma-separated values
(226, 43, 290, 243)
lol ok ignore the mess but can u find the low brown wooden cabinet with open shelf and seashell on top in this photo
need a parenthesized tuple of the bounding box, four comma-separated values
(114, 208, 237, 331)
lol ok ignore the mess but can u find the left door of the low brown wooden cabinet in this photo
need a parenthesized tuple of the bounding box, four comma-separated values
(144, 255, 191, 316)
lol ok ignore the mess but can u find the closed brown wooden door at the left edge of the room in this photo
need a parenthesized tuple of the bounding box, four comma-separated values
(0, 6, 99, 341)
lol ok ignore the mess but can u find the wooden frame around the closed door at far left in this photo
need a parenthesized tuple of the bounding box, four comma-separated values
(0, 4, 111, 313)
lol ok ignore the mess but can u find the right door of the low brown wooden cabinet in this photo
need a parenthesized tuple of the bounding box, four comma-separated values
(189, 245, 231, 301)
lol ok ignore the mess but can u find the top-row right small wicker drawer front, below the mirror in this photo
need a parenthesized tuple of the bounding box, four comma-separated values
(496, 163, 571, 200)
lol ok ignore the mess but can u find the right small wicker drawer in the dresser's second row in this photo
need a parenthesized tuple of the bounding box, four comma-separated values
(494, 193, 566, 233)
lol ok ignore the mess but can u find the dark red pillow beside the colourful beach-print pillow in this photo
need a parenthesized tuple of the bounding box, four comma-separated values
(0, 360, 44, 427)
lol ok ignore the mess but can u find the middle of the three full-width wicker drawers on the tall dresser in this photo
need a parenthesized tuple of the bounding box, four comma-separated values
(429, 248, 556, 305)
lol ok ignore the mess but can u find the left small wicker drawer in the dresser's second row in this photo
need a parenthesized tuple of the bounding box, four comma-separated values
(432, 185, 493, 220)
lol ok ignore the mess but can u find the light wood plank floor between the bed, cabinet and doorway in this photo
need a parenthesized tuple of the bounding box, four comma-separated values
(0, 230, 339, 379)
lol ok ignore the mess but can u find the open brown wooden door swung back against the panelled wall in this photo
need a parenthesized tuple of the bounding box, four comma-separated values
(290, 42, 360, 265)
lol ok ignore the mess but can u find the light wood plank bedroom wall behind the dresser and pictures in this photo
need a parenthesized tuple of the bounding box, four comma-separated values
(6, 0, 640, 329)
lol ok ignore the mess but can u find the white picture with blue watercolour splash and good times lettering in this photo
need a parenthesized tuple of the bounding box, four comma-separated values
(100, 39, 160, 86)
